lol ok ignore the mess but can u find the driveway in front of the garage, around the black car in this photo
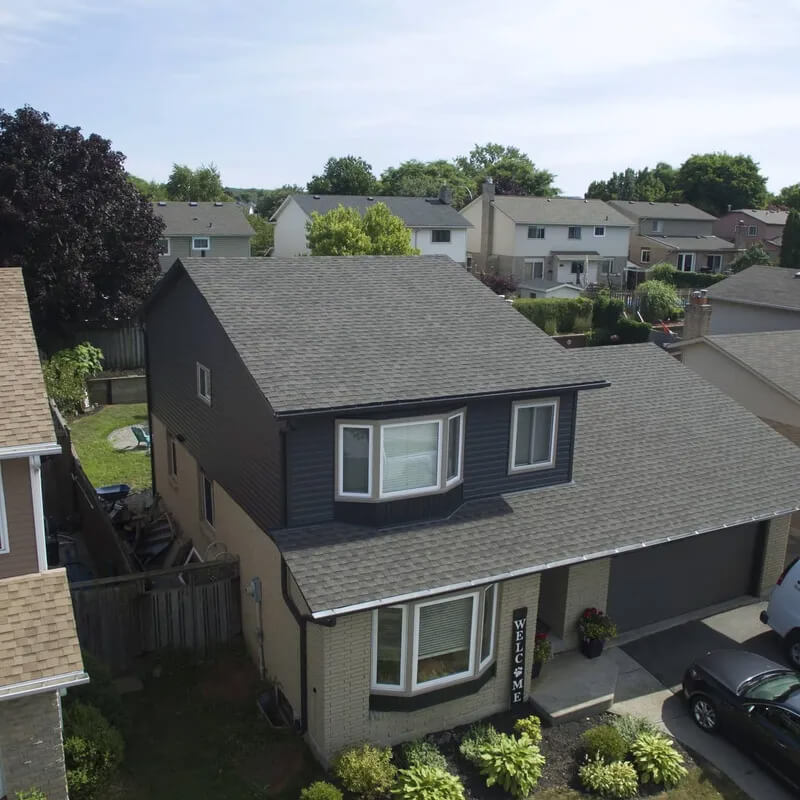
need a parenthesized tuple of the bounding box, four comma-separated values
(608, 603, 795, 800)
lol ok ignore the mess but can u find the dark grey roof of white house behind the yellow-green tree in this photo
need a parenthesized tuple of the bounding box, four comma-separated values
(282, 194, 472, 228)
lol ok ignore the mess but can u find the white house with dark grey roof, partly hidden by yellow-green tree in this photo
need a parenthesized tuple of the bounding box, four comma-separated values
(270, 188, 469, 264)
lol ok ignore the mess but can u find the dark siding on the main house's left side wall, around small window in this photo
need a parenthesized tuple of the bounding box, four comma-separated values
(145, 275, 284, 530)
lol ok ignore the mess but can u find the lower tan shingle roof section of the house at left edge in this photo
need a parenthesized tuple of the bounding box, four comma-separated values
(0, 569, 87, 700)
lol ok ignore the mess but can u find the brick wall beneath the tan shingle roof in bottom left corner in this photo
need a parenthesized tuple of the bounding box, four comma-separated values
(0, 692, 67, 800)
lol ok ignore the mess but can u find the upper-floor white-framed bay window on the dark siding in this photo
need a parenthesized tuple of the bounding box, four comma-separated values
(336, 409, 466, 501)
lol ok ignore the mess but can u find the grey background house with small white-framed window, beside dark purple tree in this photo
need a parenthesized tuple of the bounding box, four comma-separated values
(152, 200, 255, 272)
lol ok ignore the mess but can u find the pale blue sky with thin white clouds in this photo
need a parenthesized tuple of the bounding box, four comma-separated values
(0, 0, 800, 195)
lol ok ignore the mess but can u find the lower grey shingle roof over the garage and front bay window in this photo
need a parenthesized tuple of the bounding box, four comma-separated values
(272, 344, 800, 617)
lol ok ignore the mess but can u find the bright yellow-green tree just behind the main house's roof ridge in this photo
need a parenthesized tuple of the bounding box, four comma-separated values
(306, 203, 419, 256)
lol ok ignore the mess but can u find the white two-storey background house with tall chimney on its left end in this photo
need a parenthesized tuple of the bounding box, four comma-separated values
(461, 181, 633, 296)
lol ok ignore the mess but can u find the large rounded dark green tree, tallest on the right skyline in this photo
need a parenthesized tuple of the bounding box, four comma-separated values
(678, 153, 767, 216)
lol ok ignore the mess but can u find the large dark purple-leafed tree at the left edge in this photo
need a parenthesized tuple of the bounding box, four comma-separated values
(0, 106, 163, 344)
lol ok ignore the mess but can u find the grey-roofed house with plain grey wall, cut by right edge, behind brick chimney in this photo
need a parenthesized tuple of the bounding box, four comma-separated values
(708, 265, 800, 334)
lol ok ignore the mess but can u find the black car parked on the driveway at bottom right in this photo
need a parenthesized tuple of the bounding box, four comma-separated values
(683, 650, 800, 788)
